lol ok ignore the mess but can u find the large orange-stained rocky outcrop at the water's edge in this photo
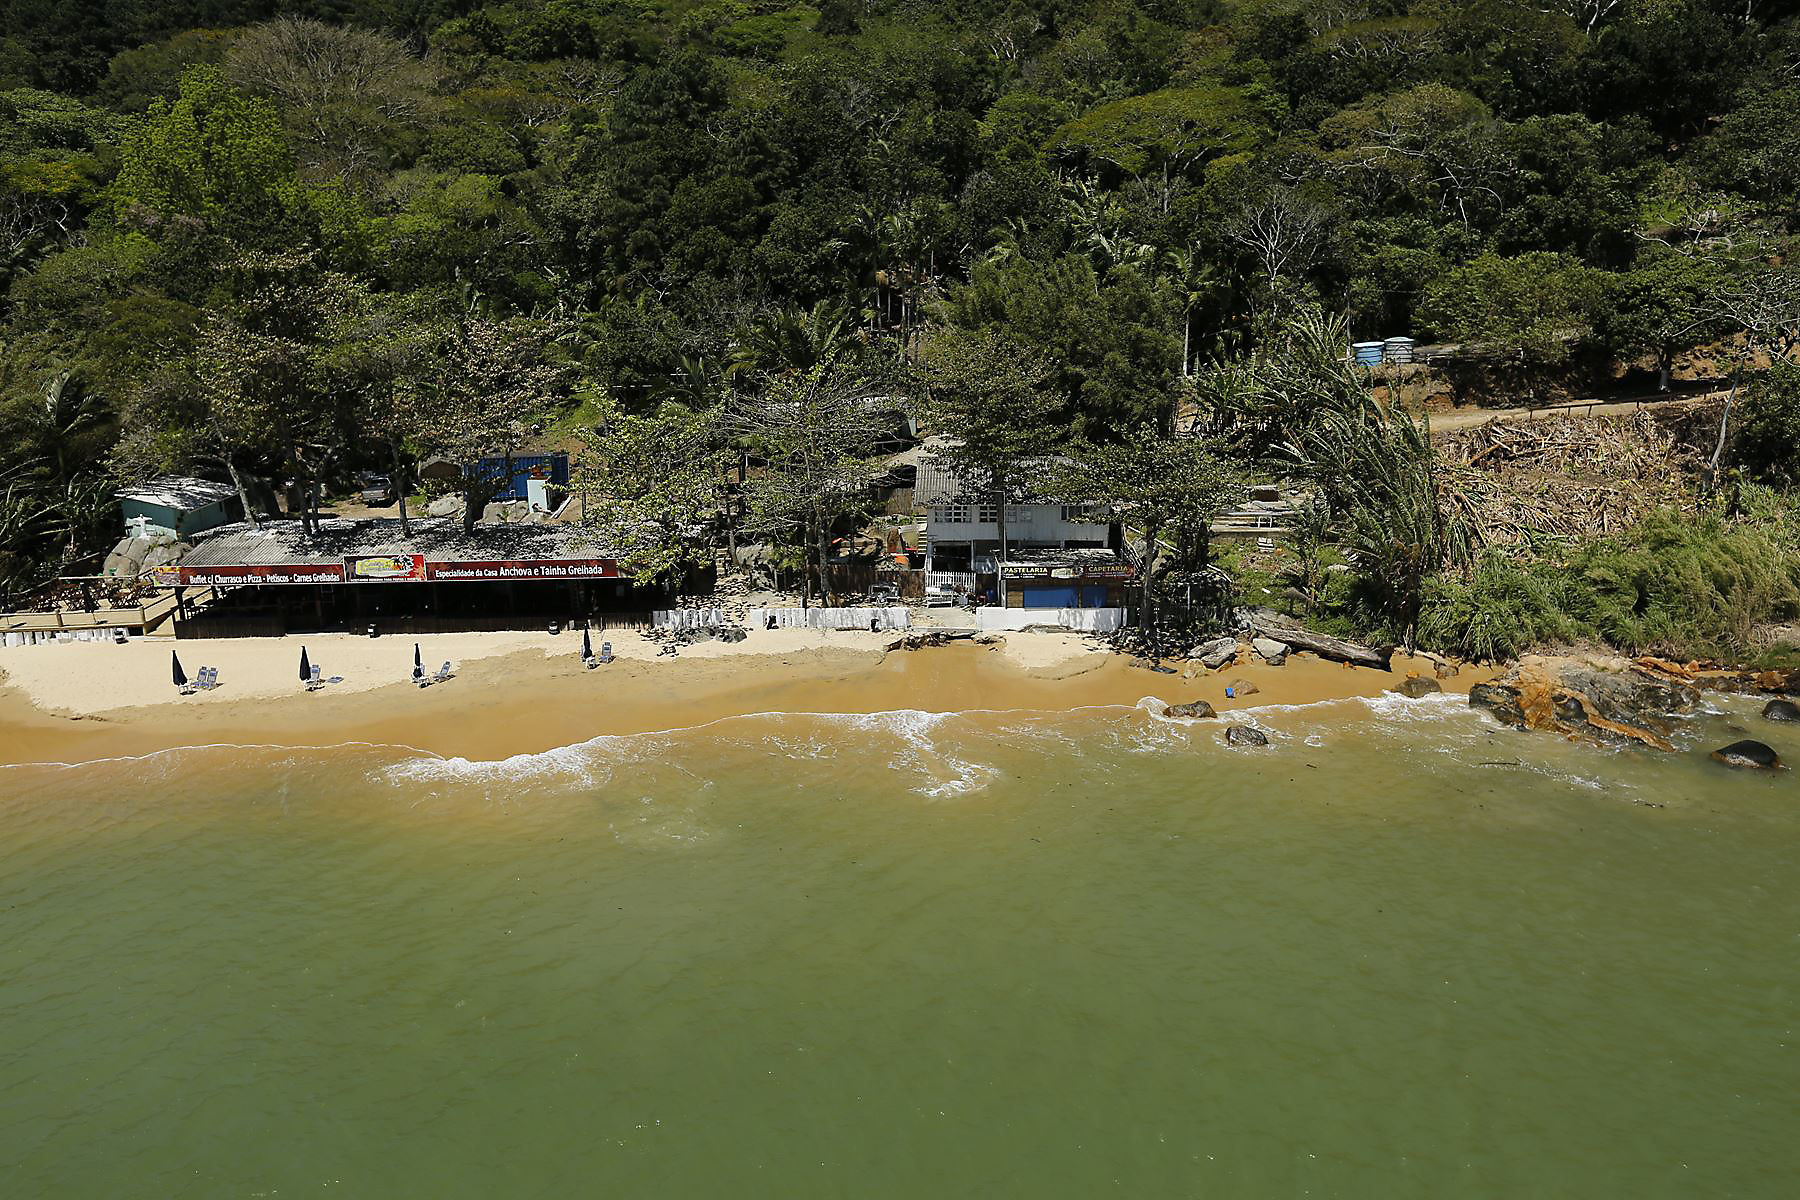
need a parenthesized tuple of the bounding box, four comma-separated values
(1469, 655, 1699, 750)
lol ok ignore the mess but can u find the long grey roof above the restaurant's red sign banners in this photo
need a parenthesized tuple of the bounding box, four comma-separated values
(182, 516, 614, 567)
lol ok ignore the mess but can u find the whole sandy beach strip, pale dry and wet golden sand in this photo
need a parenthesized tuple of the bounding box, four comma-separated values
(0, 630, 1481, 763)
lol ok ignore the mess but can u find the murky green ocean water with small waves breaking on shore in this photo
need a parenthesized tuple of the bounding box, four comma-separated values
(0, 700, 1800, 1198)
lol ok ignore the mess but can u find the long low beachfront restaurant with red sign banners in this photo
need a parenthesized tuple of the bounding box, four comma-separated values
(167, 518, 693, 637)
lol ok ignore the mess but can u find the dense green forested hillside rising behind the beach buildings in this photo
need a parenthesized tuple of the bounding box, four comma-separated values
(0, 0, 1800, 651)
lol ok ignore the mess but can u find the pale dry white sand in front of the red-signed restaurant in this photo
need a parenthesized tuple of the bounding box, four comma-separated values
(0, 630, 895, 714)
